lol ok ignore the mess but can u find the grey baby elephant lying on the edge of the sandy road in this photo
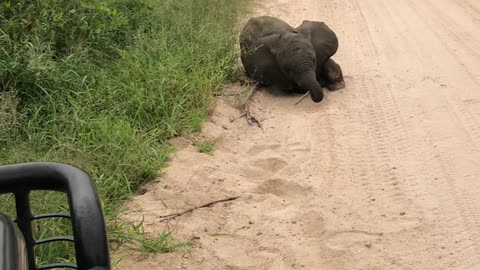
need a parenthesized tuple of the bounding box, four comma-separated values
(240, 16, 345, 102)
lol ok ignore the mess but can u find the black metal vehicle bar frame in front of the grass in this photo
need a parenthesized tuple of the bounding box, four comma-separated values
(0, 162, 111, 270)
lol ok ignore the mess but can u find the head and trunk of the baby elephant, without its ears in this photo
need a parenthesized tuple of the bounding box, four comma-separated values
(257, 31, 323, 102)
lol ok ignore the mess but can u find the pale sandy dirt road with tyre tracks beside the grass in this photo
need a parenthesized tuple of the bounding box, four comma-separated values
(121, 0, 480, 270)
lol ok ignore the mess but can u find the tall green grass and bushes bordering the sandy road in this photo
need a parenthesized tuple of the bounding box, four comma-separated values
(0, 0, 251, 262)
